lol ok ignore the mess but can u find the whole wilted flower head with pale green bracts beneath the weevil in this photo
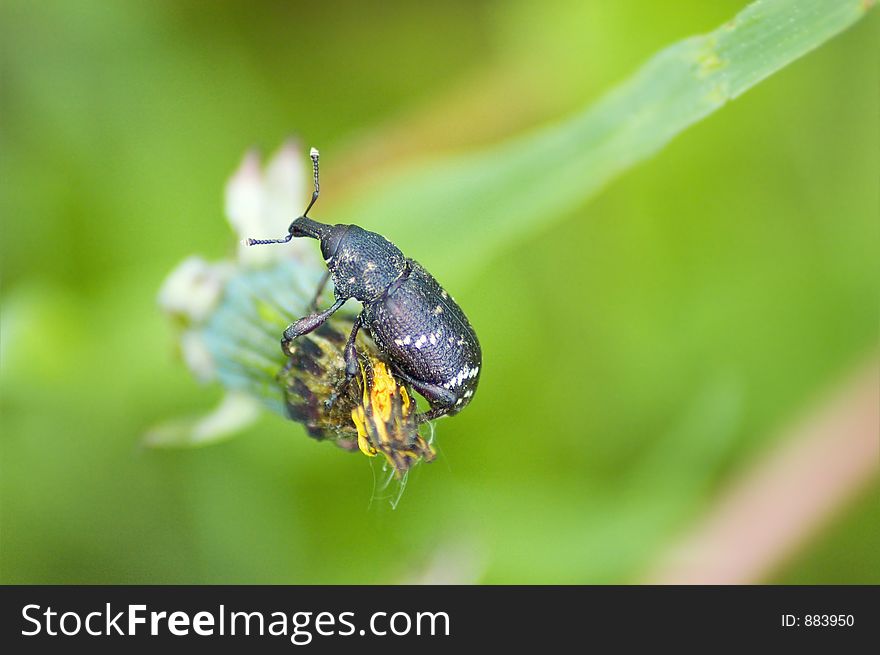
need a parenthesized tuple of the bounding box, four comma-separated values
(155, 142, 440, 486)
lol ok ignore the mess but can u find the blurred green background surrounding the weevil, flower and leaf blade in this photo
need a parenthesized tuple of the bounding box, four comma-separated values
(0, 0, 880, 583)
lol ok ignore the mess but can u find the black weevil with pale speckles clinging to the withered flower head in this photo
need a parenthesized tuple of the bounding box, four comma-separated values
(247, 148, 482, 420)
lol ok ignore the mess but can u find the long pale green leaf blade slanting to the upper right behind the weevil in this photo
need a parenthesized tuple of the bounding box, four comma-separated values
(338, 0, 873, 282)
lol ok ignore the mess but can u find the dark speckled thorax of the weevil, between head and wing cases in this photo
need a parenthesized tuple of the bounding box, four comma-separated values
(321, 225, 406, 303)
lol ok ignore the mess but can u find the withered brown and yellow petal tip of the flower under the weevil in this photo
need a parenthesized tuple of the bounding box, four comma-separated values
(278, 319, 435, 478)
